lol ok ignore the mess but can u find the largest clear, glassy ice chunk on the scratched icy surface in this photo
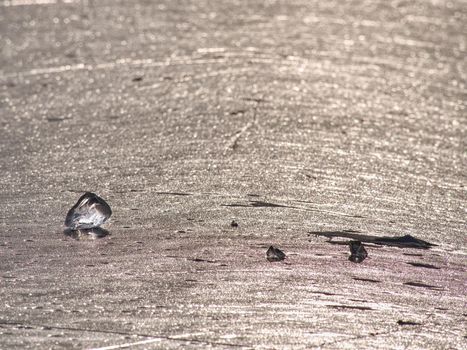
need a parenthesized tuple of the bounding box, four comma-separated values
(65, 192, 112, 230)
